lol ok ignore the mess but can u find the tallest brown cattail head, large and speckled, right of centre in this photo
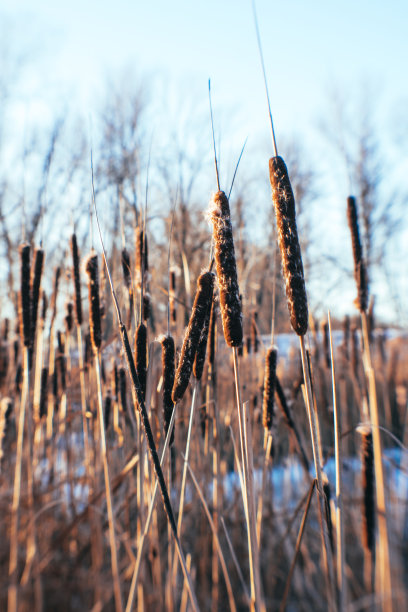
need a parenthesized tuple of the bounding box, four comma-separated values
(269, 156, 308, 336)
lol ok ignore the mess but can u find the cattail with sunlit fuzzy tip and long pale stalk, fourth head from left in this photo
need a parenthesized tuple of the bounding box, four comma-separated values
(85, 251, 123, 612)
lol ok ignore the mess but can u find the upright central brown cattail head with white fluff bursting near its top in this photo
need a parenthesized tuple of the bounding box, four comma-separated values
(208, 191, 242, 347)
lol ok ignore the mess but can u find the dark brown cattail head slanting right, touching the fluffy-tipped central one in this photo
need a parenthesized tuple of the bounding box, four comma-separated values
(172, 272, 214, 404)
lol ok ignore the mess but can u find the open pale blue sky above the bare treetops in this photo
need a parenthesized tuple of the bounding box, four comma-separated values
(3, 0, 408, 146)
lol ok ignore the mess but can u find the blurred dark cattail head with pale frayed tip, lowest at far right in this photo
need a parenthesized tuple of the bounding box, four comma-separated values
(360, 427, 375, 552)
